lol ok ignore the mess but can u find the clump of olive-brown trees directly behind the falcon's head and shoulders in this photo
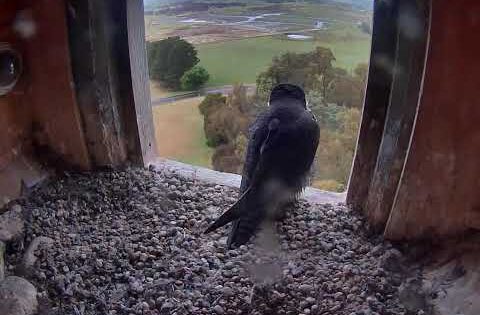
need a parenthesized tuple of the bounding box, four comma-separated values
(200, 47, 368, 191)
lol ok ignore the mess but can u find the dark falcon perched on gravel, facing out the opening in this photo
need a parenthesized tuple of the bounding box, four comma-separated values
(205, 84, 320, 248)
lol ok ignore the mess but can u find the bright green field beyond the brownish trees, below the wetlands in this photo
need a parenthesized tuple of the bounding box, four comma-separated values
(197, 30, 370, 86)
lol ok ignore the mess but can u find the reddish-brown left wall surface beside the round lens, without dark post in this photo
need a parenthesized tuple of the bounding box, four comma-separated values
(0, 0, 90, 206)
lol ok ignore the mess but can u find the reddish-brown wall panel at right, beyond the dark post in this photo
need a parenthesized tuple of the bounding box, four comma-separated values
(385, 0, 480, 239)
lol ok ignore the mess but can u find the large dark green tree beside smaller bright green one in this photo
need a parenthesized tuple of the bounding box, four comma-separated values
(147, 37, 199, 88)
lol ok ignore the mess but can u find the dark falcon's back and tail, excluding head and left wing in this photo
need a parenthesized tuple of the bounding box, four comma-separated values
(228, 106, 319, 246)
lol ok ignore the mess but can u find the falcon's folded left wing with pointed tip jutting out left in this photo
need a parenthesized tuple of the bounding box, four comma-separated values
(205, 118, 280, 243)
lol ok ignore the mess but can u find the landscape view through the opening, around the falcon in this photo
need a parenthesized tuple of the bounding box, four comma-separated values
(145, 0, 373, 192)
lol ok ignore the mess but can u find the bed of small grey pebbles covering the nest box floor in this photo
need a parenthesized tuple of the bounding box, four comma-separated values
(11, 168, 406, 315)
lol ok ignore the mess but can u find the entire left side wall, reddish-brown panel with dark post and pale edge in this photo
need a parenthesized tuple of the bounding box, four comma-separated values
(0, 0, 156, 200)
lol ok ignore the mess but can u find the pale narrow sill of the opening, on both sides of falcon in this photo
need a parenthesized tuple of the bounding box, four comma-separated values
(150, 158, 346, 204)
